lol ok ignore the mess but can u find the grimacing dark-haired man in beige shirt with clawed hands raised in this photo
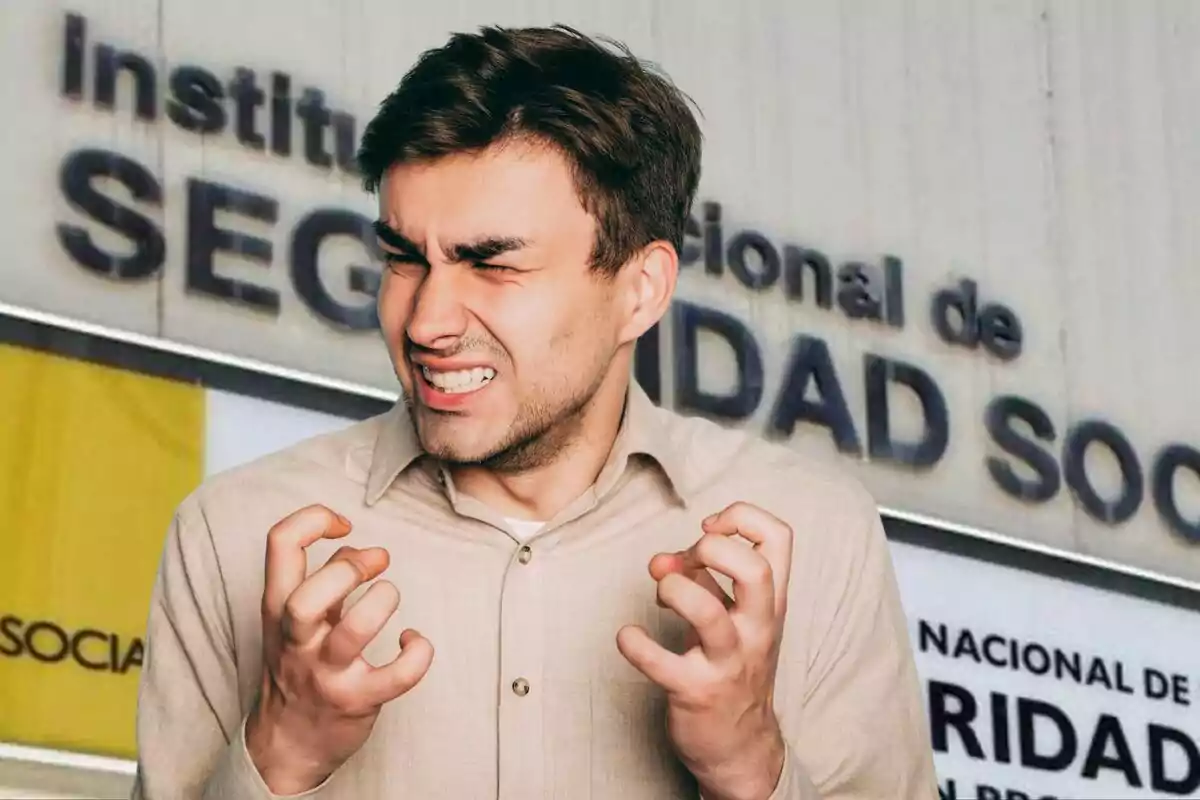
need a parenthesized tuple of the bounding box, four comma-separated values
(134, 21, 936, 800)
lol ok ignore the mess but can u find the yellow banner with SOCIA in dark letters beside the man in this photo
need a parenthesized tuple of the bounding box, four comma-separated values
(0, 345, 204, 758)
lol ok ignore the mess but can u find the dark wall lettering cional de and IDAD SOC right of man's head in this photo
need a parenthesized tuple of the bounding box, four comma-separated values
(638, 203, 1200, 554)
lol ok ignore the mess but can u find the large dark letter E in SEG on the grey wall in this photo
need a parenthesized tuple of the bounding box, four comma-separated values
(187, 179, 280, 313)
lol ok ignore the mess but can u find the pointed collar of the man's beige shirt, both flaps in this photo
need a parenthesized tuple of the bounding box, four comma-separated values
(366, 380, 688, 506)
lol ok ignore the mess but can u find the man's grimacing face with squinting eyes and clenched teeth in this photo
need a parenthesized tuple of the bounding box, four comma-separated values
(379, 142, 628, 470)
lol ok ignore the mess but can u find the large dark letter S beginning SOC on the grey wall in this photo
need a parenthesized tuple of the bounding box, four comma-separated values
(985, 395, 1062, 503)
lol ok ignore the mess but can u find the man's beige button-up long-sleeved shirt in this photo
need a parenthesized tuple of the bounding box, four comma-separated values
(133, 385, 937, 800)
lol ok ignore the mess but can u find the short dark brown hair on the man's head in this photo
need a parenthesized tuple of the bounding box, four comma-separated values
(358, 25, 702, 272)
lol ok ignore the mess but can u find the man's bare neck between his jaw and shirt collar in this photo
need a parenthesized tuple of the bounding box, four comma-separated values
(451, 372, 629, 522)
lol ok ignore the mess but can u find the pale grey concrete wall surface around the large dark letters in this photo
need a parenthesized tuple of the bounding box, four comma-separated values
(7, 0, 1200, 578)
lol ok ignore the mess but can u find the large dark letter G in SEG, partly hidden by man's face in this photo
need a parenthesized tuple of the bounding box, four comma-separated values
(292, 209, 379, 331)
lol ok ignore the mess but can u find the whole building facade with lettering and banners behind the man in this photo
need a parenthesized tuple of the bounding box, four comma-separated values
(0, 0, 1200, 800)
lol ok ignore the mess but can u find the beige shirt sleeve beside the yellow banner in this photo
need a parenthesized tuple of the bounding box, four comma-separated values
(132, 497, 312, 800)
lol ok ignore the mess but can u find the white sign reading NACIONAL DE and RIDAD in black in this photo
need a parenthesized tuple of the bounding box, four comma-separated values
(892, 542, 1200, 800)
